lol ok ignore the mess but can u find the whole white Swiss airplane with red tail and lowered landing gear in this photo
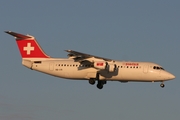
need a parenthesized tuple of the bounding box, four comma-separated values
(5, 31, 175, 89)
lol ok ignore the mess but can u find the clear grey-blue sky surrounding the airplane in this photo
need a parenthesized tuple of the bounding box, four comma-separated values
(0, 0, 180, 120)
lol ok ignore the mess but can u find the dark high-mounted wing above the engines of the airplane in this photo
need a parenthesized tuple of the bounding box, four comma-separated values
(65, 50, 113, 62)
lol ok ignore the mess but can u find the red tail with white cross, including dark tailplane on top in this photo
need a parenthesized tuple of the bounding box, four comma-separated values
(5, 31, 49, 58)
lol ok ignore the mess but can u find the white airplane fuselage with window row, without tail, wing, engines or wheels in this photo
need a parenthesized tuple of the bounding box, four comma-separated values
(23, 58, 174, 82)
